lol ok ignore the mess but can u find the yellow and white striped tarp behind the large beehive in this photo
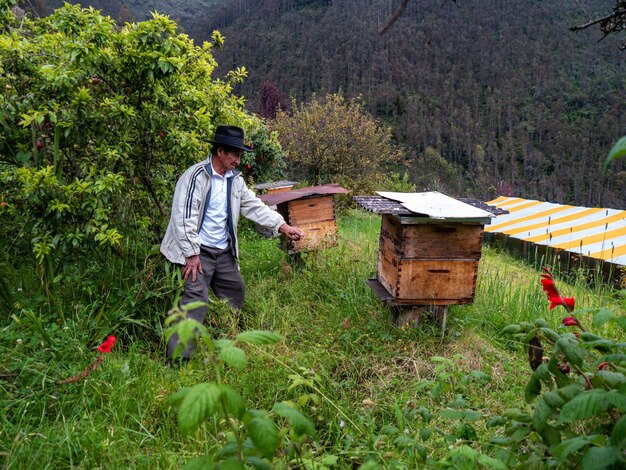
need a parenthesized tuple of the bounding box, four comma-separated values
(485, 196, 626, 265)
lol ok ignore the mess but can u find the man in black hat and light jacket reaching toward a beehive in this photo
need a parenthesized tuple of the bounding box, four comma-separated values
(161, 126, 304, 361)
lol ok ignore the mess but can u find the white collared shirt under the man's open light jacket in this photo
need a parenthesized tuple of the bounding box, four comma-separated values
(200, 162, 233, 249)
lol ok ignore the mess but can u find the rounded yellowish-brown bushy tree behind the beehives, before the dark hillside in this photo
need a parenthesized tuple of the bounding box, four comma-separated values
(271, 94, 401, 194)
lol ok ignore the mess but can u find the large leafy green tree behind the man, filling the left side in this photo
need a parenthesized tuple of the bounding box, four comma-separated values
(0, 0, 276, 288)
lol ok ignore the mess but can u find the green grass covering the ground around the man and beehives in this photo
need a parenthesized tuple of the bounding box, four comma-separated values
(0, 212, 611, 468)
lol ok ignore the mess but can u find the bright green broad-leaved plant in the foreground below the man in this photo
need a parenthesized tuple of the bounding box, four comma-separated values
(165, 302, 315, 469)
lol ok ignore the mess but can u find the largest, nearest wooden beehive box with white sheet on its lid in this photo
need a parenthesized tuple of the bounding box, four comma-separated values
(355, 192, 492, 306)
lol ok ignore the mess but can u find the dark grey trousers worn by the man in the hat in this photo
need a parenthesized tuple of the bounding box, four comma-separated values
(167, 246, 246, 359)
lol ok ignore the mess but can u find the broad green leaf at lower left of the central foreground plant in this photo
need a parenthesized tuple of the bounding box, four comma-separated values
(178, 382, 220, 432)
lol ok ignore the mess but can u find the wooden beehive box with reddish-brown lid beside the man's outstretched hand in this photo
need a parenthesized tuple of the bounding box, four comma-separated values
(259, 184, 349, 254)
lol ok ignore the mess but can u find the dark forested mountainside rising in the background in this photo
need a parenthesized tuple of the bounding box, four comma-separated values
(19, 0, 626, 208)
